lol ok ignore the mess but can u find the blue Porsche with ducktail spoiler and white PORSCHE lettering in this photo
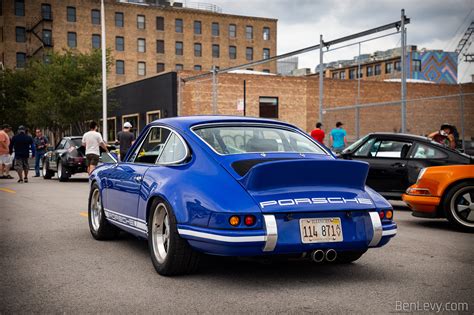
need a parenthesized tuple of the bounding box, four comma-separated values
(89, 116, 397, 275)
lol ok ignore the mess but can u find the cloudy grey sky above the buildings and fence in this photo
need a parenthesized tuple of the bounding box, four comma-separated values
(204, 0, 474, 82)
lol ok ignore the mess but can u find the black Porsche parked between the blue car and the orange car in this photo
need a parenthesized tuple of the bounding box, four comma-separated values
(340, 133, 473, 199)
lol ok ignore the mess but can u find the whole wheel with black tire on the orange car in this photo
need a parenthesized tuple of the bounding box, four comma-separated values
(443, 180, 474, 233)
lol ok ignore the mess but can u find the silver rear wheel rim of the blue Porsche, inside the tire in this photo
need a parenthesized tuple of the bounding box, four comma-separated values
(151, 203, 170, 264)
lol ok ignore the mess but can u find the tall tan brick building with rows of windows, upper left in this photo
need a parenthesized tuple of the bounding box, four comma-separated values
(0, 0, 277, 86)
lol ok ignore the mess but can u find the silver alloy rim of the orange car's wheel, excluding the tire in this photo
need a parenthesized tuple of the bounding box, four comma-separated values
(450, 186, 474, 228)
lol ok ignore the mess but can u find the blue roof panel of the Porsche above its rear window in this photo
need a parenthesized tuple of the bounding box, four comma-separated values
(151, 115, 294, 130)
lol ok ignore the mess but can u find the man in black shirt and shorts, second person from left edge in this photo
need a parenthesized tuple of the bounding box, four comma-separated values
(10, 126, 35, 183)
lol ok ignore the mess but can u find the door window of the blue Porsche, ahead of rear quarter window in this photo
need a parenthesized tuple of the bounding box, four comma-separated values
(128, 127, 170, 164)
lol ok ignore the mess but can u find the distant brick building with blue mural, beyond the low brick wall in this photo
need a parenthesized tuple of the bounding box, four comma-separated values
(316, 46, 458, 84)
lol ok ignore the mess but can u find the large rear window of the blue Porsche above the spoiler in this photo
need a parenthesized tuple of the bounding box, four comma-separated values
(194, 125, 326, 154)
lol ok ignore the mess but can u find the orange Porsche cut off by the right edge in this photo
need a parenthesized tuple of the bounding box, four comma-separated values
(403, 164, 474, 232)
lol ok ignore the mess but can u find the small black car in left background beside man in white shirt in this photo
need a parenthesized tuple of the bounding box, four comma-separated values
(43, 137, 87, 182)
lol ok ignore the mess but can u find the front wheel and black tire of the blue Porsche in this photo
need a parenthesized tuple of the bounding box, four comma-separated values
(87, 183, 119, 241)
